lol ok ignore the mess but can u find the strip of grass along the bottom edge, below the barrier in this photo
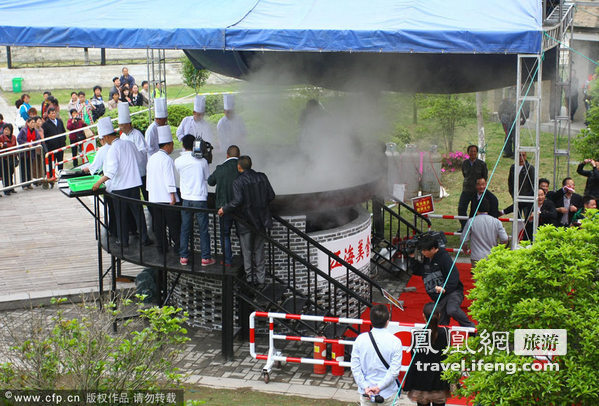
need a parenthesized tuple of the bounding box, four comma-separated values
(185, 387, 358, 406)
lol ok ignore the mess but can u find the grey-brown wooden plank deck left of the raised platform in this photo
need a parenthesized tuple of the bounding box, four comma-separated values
(0, 187, 142, 308)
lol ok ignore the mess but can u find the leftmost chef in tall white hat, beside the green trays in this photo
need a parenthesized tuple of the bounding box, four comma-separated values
(92, 117, 152, 248)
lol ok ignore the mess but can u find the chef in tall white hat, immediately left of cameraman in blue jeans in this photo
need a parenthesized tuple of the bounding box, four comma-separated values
(147, 125, 181, 254)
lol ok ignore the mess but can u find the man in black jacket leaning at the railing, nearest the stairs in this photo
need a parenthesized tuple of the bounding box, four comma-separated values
(218, 155, 275, 285)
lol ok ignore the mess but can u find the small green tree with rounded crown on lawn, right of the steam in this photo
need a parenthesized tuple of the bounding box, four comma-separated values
(422, 94, 476, 152)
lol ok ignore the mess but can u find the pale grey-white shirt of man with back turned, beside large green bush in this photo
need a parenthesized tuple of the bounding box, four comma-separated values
(462, 214, 508, 261)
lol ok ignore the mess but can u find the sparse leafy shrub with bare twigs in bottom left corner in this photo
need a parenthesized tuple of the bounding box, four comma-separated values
(0, 297, 189, 392)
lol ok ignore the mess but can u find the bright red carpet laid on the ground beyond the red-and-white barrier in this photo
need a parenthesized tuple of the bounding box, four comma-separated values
(346, 263, 476, 405)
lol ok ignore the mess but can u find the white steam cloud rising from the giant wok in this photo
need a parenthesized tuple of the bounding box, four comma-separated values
(213, 61, 390, 195)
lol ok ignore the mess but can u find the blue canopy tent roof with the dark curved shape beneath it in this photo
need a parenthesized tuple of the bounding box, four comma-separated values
(0, 0, 555, 92)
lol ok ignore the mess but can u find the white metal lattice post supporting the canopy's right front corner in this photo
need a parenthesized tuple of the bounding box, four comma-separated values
(512, 55, 543, 249)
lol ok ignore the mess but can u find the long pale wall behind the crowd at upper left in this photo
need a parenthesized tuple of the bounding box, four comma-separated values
(0, 63, 183, 92)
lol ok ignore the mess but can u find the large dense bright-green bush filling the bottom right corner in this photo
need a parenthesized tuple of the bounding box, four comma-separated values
(444, 214, 599, 406)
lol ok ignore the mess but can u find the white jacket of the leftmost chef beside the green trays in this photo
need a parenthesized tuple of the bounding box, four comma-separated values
(104, 138, 141, 192)
